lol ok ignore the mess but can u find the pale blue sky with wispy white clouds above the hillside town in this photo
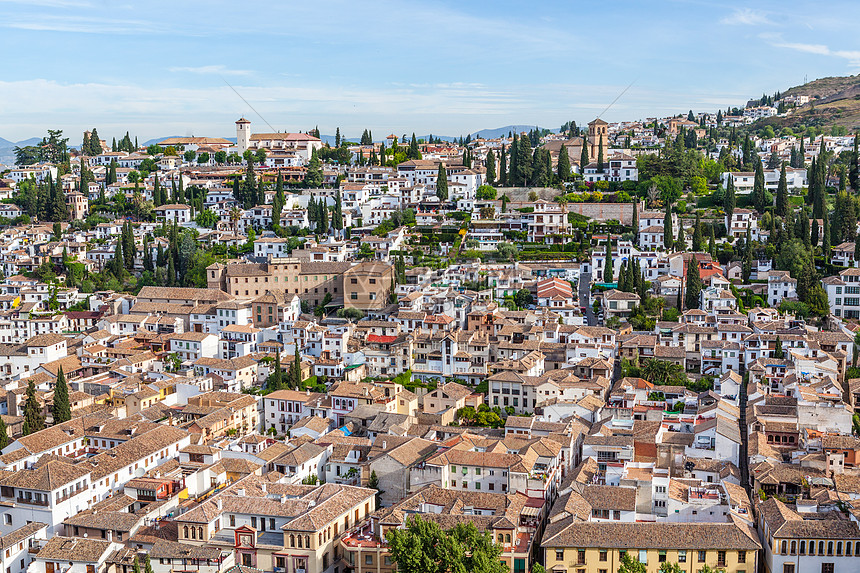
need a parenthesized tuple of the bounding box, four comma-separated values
(0, 0, 860, 144)
